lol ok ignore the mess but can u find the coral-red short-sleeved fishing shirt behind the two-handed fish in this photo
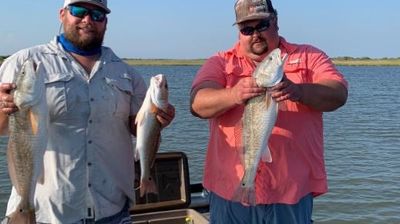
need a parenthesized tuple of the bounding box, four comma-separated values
(192, 38, 347, 204)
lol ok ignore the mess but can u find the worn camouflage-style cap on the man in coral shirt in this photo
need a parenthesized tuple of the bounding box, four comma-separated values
(234, 0, 275, 25)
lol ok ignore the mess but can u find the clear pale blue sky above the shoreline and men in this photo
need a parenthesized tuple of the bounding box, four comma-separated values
(0, 0, 400, 59)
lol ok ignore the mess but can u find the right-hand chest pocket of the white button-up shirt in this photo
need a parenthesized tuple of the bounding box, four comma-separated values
(104, 74, 133, 119)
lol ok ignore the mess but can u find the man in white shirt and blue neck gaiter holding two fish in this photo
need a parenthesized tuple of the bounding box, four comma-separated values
(0, 0, 175, 224)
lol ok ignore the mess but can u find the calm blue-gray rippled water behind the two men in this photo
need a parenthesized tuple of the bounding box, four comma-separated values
(0, 66, 400, 224)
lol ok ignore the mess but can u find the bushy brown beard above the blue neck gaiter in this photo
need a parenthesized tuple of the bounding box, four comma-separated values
(64, 26, 105, 51)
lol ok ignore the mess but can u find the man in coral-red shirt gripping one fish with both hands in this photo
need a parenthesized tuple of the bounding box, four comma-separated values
(191, 0, 348, 223)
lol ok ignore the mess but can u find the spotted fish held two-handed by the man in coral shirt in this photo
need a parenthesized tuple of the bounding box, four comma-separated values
(234, 48, 286, 204)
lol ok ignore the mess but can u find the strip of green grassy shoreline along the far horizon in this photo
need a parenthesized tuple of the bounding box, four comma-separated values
(0, 56, 400, 66)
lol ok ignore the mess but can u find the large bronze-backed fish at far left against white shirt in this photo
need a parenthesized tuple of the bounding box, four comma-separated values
(7, 60, 48, 224)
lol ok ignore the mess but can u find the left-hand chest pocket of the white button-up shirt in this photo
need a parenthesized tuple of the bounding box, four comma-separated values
(45, 73, 74, 118)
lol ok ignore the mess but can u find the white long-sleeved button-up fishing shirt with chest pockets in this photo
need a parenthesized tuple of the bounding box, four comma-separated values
(0, 39, 146, 223)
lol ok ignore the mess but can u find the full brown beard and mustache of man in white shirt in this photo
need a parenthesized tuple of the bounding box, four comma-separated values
(64, 25, 105, 51)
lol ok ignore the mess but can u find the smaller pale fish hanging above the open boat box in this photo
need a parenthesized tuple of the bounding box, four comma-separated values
(135, 74, 168, 197)
